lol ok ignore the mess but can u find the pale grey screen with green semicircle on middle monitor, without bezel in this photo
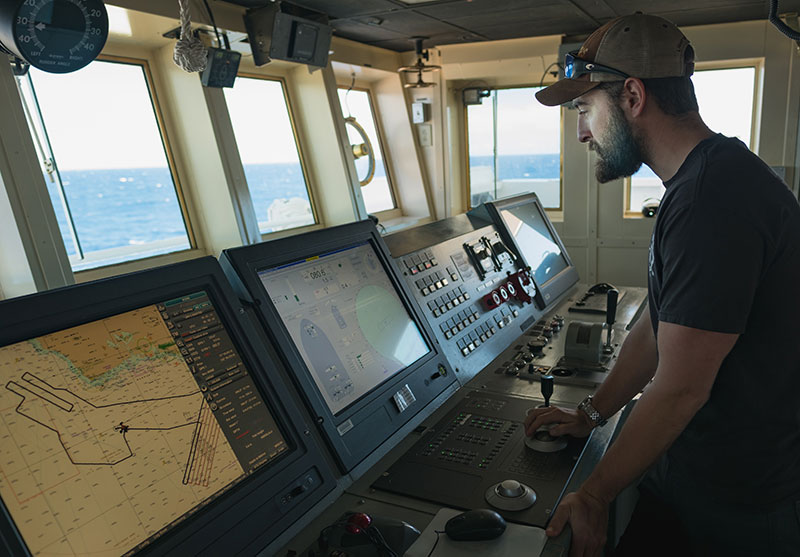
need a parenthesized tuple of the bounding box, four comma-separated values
(258, 243, 430, 414)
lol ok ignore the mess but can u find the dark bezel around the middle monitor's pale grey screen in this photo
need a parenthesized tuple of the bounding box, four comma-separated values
(222, 221, 455, 472)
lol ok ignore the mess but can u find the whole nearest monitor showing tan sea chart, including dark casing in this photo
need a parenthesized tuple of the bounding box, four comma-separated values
(0, 258, 335, 556)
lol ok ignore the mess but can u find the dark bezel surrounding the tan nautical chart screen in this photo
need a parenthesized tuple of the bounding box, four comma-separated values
(0, 257, 334, 555)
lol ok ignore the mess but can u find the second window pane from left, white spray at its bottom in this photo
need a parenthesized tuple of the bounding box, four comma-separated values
(225, 75, 317, 234)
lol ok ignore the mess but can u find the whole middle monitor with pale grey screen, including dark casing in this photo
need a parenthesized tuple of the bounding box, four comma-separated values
(220, 221, 455, 472)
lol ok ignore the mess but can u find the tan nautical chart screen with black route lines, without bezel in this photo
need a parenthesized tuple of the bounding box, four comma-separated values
(0, 291, 289, 557)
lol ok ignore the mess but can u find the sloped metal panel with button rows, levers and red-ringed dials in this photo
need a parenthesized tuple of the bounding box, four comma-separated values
(385, 215, 541, 385)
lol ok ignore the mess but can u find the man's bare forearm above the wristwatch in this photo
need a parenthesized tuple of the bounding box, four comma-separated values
(593, 310, 658, 418)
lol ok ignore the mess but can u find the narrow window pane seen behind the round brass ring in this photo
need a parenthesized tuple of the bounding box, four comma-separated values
(339, 88, 397, 214)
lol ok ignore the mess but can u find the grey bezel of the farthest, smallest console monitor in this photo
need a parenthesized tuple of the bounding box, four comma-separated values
(485, 193, 579, 309)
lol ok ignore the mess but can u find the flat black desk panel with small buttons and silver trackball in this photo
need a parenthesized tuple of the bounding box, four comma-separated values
(372, 391, 586, 527)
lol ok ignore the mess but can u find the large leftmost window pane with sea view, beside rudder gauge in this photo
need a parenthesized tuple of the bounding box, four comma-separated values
(18, 59, 192, 271)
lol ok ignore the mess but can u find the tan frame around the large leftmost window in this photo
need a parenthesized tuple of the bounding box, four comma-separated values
(24, 53, 198, 274)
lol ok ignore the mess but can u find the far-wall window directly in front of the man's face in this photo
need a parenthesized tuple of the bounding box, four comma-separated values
(467, 87, 561, 209)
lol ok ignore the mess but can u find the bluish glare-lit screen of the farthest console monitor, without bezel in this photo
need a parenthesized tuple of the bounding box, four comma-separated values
(500, 203, 568, 287)
